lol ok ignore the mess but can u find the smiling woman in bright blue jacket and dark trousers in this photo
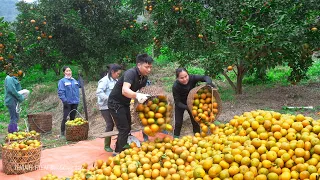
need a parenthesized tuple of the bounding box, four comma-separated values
(58, 66, 81, 136)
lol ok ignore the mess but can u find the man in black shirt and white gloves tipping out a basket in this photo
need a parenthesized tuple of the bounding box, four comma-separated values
(108, 54, 153, 153)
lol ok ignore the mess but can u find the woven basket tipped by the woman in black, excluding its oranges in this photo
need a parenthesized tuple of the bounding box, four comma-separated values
(187, 84, 222, 120)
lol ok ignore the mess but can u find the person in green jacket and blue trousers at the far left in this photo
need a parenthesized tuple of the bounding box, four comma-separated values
(4, 75, 25, 133)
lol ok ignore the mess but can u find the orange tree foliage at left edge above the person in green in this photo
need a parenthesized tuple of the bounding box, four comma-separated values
(0, 17, 23, 76)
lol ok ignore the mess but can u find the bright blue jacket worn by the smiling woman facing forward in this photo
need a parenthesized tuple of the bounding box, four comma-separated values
(58, 77, 81, 104)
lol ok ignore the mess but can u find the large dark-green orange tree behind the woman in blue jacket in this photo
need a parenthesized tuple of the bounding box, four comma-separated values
(13, 0, 152, 75)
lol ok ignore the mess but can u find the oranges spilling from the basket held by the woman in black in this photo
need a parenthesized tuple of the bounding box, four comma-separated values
(191, 86, 219, 137)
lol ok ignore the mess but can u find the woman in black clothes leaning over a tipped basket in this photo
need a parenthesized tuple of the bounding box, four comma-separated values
(172, 68, 216, 138)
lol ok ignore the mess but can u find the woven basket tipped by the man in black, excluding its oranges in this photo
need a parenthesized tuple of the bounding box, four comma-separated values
(131, 85, 174, 133)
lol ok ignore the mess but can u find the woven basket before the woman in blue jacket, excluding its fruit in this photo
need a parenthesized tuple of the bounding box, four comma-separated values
(66, 123, 89, 141)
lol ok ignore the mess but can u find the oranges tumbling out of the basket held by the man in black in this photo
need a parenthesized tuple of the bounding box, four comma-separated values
(136, 95, 172, 136)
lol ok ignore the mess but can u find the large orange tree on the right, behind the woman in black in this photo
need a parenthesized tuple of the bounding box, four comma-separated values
(151, 0, 320, 94)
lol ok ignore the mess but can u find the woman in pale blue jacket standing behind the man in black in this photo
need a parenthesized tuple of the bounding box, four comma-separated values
(96, 64, 122, 152)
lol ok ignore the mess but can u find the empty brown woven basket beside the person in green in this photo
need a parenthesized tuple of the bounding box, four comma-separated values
(28, 112, 52, 133)
